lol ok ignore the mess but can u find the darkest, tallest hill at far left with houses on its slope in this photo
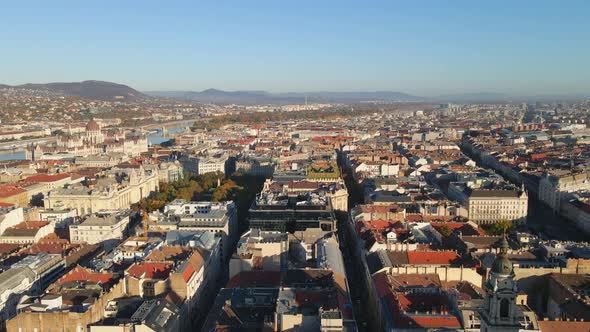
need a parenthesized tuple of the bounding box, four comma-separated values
(0, 81, 148, 101)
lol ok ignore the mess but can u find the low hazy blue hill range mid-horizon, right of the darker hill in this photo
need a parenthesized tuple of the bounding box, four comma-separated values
(145, 89, 425, 104)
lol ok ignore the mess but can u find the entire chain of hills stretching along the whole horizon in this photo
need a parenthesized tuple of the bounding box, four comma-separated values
(0, 80, 590, 105)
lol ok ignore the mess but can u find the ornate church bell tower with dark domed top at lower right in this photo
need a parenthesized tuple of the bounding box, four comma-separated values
(480, 237, 522, 332)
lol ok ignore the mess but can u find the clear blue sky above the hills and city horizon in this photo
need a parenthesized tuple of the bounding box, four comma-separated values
(0, 0, 590, 95)
